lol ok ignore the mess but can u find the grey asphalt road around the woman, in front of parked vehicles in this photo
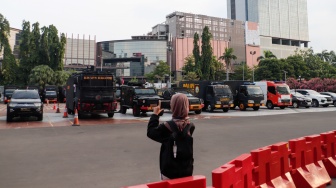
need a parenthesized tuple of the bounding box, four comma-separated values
(0, 107, 336, 188)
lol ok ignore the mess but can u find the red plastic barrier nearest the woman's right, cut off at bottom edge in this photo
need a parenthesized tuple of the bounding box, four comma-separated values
(212, 154, 255, 188)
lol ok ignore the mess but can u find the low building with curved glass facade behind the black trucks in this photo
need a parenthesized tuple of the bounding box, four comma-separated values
(96, 39, 167, 77)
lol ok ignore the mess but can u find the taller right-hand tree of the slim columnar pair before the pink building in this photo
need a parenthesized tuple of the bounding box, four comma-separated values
(200, 26, 213, 80)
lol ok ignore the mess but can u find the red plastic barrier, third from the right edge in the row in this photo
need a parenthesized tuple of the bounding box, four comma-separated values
(251, 142, 295, 188)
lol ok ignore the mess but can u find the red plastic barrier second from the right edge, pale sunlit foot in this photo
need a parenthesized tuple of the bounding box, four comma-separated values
(289, 135, 331, 187)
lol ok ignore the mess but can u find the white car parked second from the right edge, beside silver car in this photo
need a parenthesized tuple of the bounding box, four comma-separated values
(295, 89, 333, 107)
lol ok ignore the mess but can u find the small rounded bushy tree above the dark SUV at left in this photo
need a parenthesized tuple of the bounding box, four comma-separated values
(29, 65, 56, 89)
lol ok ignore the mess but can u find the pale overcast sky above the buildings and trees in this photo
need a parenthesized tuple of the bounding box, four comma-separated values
(0, 0, 336, 52)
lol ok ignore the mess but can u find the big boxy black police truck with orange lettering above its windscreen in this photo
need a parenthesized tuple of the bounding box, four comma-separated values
(66, 69, 117, 118)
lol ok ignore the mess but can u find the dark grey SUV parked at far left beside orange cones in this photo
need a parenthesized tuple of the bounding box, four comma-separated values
(7, 90, 43, 122)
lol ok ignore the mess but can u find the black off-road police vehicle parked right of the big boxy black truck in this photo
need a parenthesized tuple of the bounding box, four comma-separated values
(120, 83, 161, 117)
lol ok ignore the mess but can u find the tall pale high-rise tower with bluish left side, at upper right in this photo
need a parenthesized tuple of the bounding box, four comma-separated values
(227, 0, 309, 58)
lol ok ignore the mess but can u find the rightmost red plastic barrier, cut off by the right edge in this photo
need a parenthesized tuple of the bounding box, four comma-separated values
(321, 131, 336, 178)
